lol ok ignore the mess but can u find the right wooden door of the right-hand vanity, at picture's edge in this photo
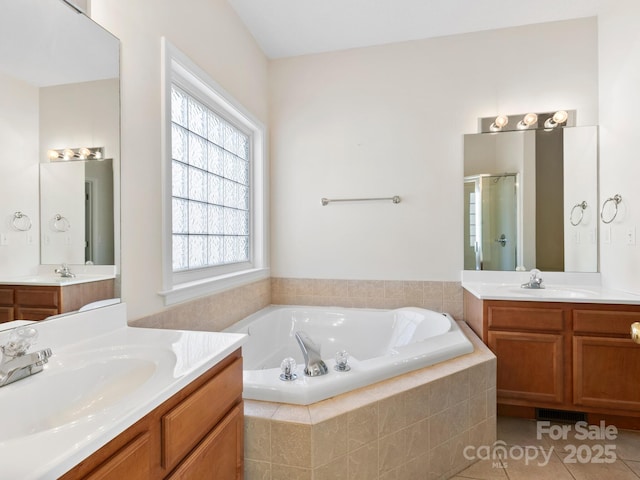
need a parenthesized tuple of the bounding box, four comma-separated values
(573, 336, 640, 411)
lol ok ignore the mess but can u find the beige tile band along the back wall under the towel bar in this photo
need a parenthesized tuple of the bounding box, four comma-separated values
(271, 277, 462, 320)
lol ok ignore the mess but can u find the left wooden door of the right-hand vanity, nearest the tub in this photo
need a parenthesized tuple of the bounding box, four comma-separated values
(489, 331, 564, 403)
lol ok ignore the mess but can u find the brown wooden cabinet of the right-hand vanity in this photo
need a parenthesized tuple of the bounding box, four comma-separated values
(464, 291, 640, 428)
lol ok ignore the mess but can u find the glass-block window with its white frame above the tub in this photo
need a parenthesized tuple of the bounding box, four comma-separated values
(161, 40, 268, 304)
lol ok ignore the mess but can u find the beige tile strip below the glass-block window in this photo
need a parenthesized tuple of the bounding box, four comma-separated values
(129, 278, 271, 332)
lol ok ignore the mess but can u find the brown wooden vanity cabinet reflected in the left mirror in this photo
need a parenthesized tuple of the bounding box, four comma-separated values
(0, 279, 114, 323)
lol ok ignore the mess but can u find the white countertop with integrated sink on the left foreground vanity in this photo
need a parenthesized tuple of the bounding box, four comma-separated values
(0, 304, 246, 480)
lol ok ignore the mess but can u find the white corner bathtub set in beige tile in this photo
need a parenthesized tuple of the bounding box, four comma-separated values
(226, 306, 473, 405)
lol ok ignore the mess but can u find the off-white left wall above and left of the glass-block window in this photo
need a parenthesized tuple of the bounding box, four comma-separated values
(91, 0, 267, 319)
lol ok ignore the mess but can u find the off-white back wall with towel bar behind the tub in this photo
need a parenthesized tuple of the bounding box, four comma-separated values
(269, 18, 598, 281)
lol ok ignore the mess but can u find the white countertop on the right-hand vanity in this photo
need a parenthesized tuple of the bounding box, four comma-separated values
(462, 281, 640, 305)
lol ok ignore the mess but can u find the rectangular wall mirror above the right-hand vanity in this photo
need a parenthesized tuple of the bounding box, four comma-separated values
(464, 126, 598, 272)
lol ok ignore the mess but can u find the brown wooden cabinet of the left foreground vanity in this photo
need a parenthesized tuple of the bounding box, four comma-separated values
(61, 350, 244, 480)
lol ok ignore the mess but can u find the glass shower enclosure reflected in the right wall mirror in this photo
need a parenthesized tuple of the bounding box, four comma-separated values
(464, 173, 518, 270)
